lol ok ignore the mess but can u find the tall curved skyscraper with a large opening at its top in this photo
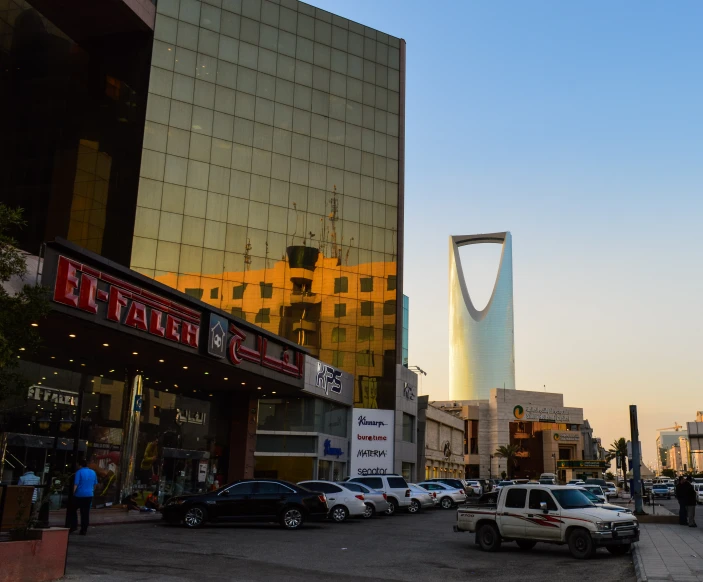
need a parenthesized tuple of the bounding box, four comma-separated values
(449, 232, 515, 400)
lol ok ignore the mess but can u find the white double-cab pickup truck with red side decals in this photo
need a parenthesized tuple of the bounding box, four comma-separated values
(454, 485, 640, 559)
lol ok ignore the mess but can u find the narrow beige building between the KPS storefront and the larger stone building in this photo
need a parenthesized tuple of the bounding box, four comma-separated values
(417, 396, 466, 479)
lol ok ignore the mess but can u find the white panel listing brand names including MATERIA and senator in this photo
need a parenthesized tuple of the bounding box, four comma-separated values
(349, 408, 395, 477)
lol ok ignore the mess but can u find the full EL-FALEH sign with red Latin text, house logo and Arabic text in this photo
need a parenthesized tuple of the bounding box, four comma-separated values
(53, 256, 303, 378)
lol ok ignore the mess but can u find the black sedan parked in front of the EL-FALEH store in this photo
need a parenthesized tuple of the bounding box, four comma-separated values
(162, 479, 328, 529)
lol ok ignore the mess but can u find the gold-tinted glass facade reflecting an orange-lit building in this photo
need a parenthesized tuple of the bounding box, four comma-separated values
(130, 0, 404, 408)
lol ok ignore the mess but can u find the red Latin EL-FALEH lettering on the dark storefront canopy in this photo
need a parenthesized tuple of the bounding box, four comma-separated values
(53, 256, 201, 350)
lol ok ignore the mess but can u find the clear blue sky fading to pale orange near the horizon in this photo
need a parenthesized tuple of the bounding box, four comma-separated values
(313, 0, 703, 464)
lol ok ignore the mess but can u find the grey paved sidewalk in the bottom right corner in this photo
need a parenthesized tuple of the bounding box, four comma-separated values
(632, 523, 703, 582)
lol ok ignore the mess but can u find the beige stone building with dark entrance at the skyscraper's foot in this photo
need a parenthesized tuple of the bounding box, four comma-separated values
(432, 388, 609, 481)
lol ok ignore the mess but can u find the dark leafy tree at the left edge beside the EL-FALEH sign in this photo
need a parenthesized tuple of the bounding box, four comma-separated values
(0, 204, 49, 401)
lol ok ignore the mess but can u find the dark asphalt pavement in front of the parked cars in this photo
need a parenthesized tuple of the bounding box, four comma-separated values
(66, 510, 635, 582)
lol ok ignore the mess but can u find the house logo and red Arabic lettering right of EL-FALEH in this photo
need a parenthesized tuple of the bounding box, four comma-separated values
(207, 313, 304, 378)
